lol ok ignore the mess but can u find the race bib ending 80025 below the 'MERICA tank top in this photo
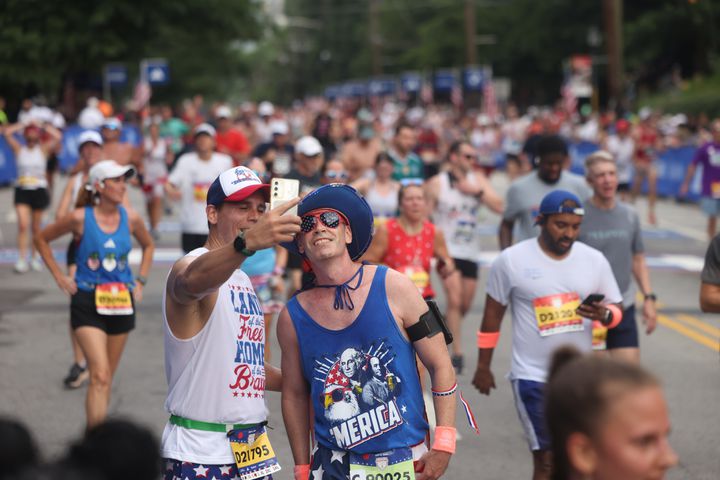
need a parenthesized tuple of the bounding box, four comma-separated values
(350, 447, 415, 480)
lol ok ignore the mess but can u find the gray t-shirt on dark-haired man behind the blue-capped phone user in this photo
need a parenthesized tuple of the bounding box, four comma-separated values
(503, 171, 592, 243)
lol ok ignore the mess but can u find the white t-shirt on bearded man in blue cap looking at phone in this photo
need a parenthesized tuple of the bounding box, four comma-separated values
(487, 238, 622, 382)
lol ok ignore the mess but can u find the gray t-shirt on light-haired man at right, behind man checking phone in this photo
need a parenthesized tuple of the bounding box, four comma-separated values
(578, 201, 645, 308)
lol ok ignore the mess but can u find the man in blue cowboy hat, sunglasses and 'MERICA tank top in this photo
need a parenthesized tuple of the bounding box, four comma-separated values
(278, 184, 457, 480)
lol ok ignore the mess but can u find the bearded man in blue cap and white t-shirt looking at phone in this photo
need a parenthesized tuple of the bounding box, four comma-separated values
(473, 190, 622, 480)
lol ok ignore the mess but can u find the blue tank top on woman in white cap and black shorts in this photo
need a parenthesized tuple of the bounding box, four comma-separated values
(75, 206, 133, 291)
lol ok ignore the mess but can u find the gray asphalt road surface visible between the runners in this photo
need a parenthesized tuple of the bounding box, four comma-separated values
(0, 173, 720, 480)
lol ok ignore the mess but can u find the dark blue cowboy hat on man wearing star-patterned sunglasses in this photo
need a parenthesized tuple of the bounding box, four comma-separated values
(281, 183, 374, 260)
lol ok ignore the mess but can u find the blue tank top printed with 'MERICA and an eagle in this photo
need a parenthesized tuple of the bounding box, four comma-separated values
(287, 266, 428, 454)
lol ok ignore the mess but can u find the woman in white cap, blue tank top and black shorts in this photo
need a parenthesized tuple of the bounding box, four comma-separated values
(35, 160, 155, 428)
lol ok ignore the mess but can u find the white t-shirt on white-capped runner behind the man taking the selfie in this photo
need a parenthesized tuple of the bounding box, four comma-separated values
(168, 152, 233, 235)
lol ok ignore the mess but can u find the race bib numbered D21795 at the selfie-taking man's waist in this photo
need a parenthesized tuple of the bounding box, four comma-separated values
(228, 425, 281, 480)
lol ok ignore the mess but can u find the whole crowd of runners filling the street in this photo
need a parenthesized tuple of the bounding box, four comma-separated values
(2, 96, 720, 480)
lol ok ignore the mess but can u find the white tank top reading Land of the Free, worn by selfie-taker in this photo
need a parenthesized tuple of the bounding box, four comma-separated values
(162, 248, 267, 464)
